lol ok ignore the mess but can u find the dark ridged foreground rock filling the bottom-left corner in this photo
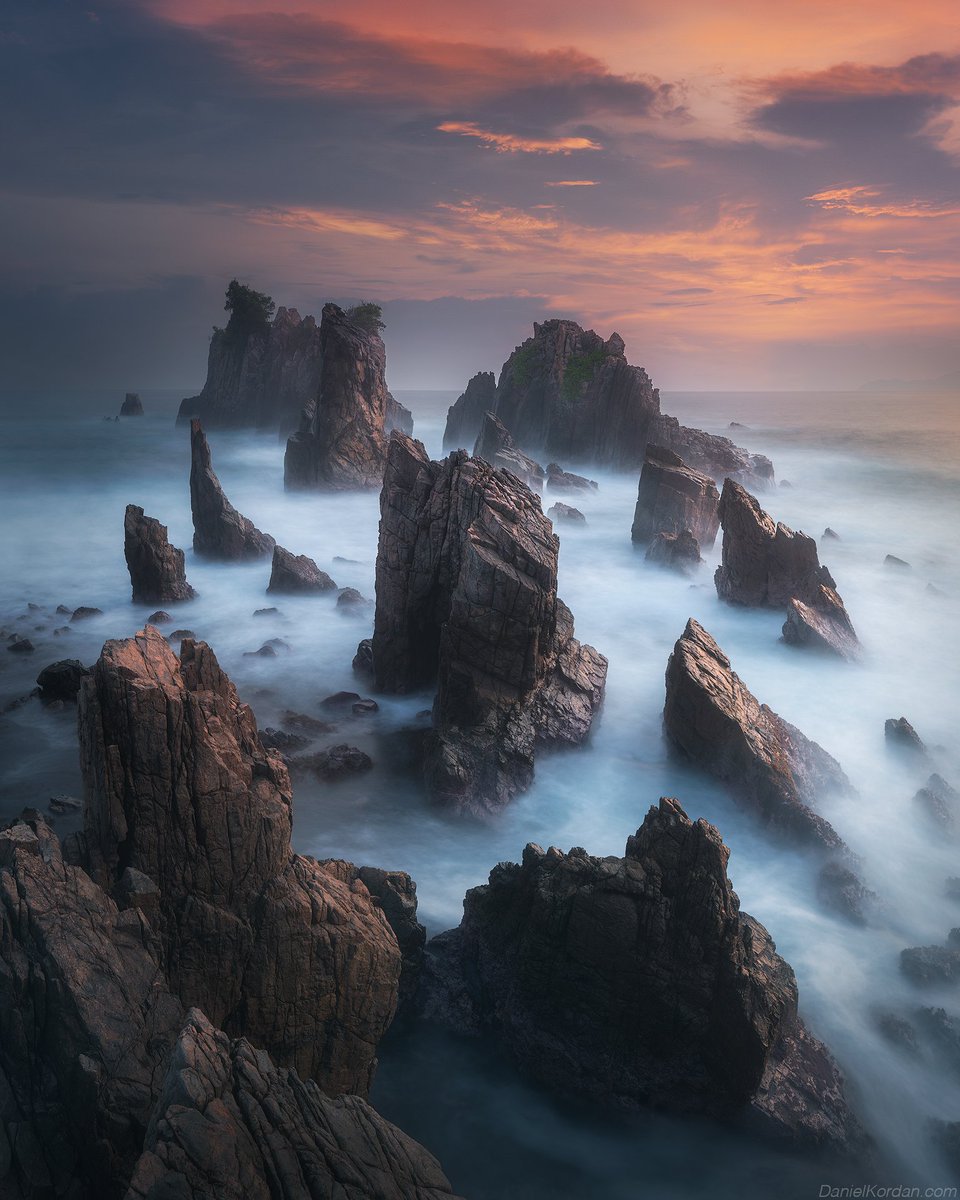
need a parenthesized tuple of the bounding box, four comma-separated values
(0, 814, 460, 1200)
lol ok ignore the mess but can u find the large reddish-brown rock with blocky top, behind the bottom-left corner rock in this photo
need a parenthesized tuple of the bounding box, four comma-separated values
(80, 629, 400, 1094)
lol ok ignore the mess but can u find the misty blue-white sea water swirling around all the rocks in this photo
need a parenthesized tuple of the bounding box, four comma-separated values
(0, 392, 960, 1200)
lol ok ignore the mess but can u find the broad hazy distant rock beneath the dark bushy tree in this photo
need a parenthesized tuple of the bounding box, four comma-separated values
(176, 307, 322, 434)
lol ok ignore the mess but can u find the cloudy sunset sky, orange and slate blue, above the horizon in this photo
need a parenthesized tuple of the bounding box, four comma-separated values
(0, 0, 960, 390)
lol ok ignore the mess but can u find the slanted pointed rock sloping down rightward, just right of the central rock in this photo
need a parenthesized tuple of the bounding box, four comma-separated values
(664, 618, 850, 848)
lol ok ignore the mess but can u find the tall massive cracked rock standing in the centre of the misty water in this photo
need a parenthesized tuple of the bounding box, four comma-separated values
(364, 433, 607, 811)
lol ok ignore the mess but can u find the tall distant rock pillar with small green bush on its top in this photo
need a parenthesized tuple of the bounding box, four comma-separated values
(283, 304, 390, 491)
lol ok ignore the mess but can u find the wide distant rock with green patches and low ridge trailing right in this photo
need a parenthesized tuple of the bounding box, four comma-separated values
(444, 320, 773, 486)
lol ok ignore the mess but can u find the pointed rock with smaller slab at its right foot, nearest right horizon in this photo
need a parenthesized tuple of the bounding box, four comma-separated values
(714, 479, 859, 659)
